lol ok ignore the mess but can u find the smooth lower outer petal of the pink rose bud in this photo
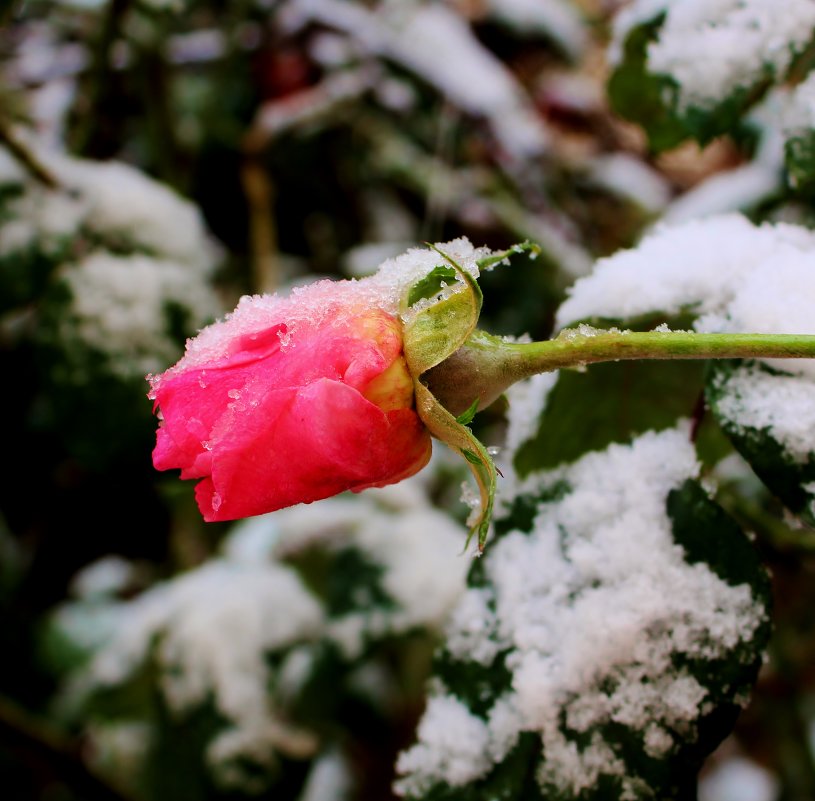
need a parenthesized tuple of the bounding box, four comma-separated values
(196, 379, 430, 521)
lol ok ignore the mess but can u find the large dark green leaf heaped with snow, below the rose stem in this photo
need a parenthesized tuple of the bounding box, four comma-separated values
(396, 432, 769, 801)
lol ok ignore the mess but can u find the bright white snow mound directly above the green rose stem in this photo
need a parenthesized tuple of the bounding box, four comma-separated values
(556, 214, 815, 378)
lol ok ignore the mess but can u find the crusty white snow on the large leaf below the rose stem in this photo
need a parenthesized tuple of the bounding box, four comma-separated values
(396, 424, 765, 798)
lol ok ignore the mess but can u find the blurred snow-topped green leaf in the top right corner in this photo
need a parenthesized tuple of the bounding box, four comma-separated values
(609, 0, 815, 151)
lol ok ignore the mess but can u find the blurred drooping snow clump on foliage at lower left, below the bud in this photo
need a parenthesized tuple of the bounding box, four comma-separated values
(78, 559, 323, 784)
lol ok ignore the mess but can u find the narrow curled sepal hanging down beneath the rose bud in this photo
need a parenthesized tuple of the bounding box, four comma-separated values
(416, 381, 498, 553)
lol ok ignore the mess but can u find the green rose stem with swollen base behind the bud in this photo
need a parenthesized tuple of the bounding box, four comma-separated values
(424, 327, 815, 414)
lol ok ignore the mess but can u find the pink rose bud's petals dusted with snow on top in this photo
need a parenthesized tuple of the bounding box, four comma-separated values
(148, 281, 431, 521)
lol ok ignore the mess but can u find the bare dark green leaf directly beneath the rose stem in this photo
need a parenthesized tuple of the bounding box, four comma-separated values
(514, 361, 704, 476)
